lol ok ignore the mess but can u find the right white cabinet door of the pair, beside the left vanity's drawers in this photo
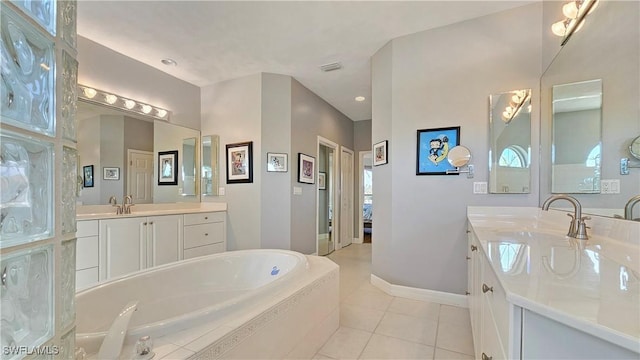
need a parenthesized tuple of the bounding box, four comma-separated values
(147, 215, 183, 267)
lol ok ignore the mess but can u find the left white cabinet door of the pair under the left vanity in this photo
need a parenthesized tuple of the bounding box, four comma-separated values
(99, 218, 147, 281)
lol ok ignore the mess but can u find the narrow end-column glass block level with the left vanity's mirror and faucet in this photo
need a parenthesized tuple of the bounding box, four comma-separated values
(60, 146, 78, 234)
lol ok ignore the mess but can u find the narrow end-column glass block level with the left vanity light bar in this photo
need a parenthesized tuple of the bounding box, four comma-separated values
(61, 51, 78, 142)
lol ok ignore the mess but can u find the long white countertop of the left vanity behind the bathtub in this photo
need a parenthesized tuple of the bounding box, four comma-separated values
(76, 202, 227, 220)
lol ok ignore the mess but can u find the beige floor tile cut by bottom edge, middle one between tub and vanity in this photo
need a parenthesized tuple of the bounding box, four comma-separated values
(360, 334, 434, 360)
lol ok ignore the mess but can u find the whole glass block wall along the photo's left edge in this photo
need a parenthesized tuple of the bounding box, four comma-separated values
(0, 0, 79, 359)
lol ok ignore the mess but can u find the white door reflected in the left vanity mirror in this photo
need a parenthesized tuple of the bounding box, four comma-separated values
(127, 149, 153, 204)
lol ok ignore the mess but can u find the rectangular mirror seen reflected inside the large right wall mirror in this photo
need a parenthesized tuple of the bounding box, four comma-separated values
(551, 80, 602, 194)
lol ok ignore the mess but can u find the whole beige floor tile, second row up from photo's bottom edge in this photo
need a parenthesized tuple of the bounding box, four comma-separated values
(375, 312, 438, 346)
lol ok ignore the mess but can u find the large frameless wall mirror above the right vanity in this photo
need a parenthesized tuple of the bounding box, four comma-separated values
(539, 1, 640, 216)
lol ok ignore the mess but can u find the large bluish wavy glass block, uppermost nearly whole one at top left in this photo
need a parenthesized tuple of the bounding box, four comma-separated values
(0, 2, 55, 136)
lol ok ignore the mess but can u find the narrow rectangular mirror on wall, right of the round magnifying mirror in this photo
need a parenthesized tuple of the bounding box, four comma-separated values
(489, 89, 531, 194)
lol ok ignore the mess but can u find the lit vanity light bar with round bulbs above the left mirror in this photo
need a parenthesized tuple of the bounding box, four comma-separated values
(78, 84, 171, 121)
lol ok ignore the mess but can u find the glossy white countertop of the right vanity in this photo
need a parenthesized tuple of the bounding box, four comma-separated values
(467, 207, 640, 353)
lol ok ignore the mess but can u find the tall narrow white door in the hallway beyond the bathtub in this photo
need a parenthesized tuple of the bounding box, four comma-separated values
(340, 147, 353, 247)
